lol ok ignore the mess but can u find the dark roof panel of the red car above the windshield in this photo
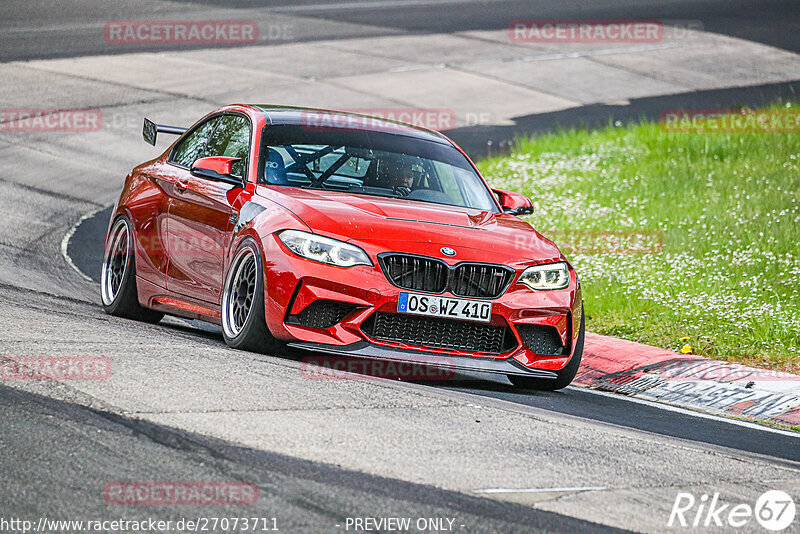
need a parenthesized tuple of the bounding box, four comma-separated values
(251, 104, 453, 146)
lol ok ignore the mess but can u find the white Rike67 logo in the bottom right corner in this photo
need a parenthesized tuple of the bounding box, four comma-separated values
(667, 490, 795, 532)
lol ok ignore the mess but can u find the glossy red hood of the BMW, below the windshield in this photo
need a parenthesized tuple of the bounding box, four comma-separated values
(257, 186, 561, 264)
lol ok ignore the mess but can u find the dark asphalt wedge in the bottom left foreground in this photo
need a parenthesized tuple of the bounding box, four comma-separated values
(0, 386, 621, 533)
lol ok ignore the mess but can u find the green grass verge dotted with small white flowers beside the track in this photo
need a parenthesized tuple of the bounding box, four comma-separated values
(479, 104, 800, 372)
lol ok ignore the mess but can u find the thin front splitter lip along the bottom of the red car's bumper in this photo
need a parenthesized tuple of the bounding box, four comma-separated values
(289, 341, 558, 380)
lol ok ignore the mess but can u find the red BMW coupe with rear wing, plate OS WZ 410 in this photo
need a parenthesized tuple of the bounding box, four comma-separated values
(102, 105, 584, 389)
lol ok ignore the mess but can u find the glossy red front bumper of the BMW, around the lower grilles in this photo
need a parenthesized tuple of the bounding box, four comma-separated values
(263, 235, 581, 378)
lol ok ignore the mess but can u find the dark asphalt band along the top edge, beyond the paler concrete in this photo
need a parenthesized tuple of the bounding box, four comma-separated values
(0, 0, 800, 61)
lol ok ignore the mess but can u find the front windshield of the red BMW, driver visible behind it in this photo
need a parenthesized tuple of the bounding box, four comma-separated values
(259, 125, 497, 211)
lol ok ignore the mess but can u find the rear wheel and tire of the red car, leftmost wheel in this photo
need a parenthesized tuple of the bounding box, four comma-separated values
(100, 215, 164, 323)
